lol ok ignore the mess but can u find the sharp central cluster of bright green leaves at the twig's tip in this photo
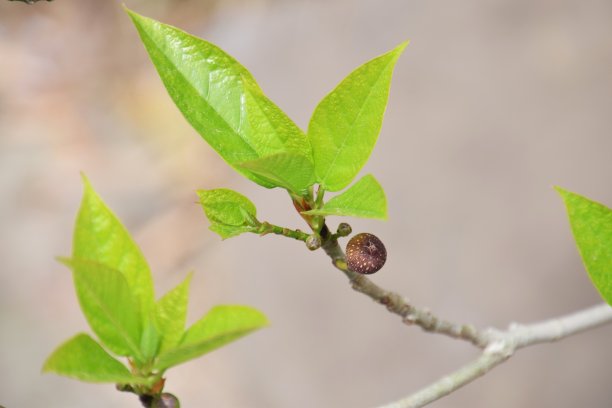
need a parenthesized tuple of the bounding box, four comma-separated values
(128, 11, 407, 238)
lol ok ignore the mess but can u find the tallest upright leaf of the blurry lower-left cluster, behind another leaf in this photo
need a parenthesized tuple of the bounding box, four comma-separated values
(72, 176, 154, 322)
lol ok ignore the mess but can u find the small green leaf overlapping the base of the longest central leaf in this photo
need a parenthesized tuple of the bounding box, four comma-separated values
(240, 153, 314, 196)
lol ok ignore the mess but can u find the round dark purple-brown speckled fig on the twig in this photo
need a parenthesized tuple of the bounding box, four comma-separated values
(346, 232, 387, 275)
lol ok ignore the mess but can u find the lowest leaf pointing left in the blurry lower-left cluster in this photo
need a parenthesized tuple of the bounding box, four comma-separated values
(43, 333, 144, 384)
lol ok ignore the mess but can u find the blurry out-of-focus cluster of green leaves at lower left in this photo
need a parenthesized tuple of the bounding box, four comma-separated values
(43, 177, 267, 395)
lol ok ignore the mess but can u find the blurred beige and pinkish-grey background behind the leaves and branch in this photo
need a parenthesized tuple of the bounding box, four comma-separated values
(0, 0, 612, 408)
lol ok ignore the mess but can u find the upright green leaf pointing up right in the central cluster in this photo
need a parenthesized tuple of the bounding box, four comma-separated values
(308, 42, 408, 191)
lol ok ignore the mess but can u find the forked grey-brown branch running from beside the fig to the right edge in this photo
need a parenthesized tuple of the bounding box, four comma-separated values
(321, 226, 612, 408)
